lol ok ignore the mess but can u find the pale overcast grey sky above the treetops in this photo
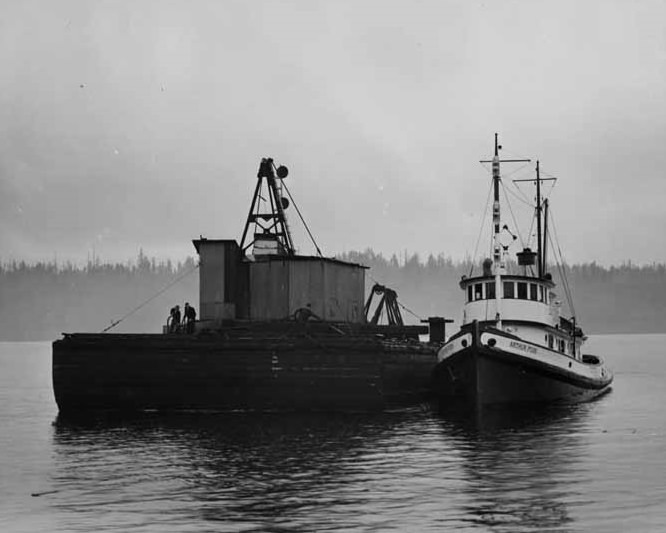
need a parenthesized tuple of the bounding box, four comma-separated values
(0, 0, 666, 265)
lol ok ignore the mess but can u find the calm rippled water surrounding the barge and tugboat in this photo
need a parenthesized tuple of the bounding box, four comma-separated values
(0, 335, 666, 532)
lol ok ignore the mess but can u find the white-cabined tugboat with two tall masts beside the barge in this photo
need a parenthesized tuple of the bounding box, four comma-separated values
(433, 134, 613, 406)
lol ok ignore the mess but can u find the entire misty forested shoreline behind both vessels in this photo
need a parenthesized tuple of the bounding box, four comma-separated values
(0, 249, 666, 341)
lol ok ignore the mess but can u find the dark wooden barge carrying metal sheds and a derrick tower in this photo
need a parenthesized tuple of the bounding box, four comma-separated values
(53, 158, 446, 415)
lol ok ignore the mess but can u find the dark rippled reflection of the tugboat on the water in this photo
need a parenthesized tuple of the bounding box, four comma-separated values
(442, 405, 589, 531)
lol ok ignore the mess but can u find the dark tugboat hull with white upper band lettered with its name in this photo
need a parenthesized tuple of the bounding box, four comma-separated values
(433, 331, 612, 405)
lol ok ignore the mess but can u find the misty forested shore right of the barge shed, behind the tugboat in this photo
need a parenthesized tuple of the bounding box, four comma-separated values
(339, 249, 666, 334)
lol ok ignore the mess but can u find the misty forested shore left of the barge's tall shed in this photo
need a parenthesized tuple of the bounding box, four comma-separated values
(0, 252, 199, 341)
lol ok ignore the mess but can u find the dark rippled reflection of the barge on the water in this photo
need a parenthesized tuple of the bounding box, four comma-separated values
(55, 414, 416, 530)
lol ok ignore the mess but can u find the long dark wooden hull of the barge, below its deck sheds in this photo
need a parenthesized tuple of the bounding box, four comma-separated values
(53, 334, 437, 413)
